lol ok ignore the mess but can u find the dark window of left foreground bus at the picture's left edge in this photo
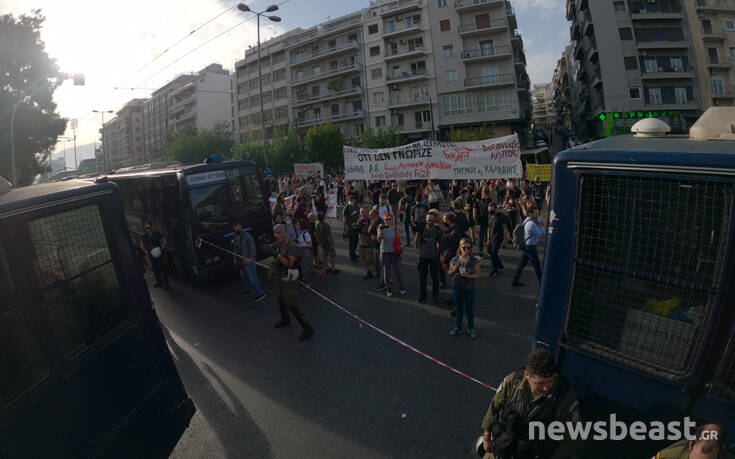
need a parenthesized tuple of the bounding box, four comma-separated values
(0, 246, 49, 411)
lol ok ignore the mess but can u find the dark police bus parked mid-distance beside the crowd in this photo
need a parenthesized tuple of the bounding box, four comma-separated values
(103, 161, 273, 280)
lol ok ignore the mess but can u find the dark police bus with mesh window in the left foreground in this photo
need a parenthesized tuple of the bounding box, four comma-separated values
(0, 178, 194, 458)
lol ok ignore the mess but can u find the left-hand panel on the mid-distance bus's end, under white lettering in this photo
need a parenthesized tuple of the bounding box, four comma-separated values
(185, 169, 234, 277)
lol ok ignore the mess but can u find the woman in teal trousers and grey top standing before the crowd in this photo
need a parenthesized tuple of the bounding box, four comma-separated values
(449, 238, 482, 339)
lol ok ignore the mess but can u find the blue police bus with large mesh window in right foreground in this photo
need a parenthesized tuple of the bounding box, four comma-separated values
(534, 108, 735, 458)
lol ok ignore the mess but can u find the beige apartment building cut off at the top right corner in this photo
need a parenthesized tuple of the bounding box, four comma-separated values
(686, 0, 735, 106)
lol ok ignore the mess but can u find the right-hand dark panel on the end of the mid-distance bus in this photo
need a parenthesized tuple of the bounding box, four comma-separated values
(227, 167, 273, 252)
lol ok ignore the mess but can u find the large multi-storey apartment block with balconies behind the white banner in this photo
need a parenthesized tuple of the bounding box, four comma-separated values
(236, 0, 530, 145)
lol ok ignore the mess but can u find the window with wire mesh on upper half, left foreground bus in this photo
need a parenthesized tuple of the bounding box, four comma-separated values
(28, 206, 133, 358)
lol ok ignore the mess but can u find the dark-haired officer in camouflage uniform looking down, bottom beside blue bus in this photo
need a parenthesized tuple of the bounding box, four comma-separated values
(482, 349, 579, 459)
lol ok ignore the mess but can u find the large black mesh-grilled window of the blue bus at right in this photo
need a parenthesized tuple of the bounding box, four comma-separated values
(566, 174, 733, 380)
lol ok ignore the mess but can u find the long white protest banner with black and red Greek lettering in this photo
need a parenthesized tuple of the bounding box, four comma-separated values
(343, 134, 523, 180)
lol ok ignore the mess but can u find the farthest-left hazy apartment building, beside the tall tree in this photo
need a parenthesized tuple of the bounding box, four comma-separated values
(102, 99, 146, 170)
